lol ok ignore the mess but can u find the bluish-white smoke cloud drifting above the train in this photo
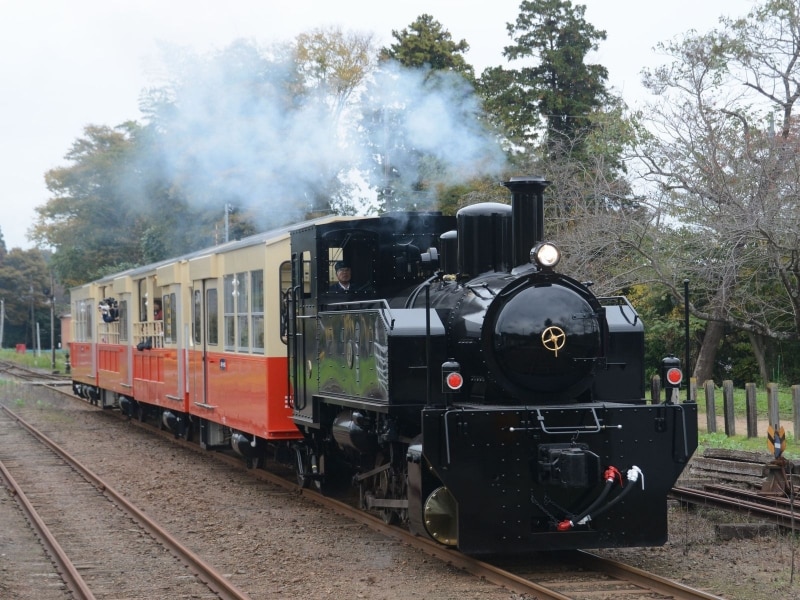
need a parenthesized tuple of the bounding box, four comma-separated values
(146, 42, 503, 229)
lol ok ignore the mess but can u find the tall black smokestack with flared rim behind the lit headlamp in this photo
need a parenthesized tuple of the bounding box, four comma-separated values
(503, 177, 550, 266)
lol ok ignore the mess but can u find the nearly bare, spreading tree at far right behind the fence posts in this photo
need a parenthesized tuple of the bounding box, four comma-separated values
(628, 0, 800, 380)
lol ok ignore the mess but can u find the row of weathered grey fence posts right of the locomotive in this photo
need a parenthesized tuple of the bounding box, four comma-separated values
(650, 376, 800, 441)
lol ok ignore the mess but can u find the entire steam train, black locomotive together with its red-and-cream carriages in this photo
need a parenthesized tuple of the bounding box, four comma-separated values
(70, 178, 697, 555)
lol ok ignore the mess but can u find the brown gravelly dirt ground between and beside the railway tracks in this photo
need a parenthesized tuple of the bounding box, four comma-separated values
(0, 386, 800, 600)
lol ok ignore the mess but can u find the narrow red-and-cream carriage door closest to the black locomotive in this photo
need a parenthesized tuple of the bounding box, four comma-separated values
(188, 279, 219, 406)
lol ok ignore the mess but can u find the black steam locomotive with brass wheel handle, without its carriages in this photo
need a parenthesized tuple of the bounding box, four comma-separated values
(285, 178, 697, 554)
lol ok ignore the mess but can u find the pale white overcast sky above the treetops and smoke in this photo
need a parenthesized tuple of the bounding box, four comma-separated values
(0, 0, 753, 249)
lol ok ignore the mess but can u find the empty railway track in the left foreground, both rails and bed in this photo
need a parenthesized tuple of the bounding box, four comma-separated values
(0, 407, 247, 600)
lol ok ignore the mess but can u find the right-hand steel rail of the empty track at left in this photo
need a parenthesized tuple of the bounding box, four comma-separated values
(0, 405, 250, 600)
